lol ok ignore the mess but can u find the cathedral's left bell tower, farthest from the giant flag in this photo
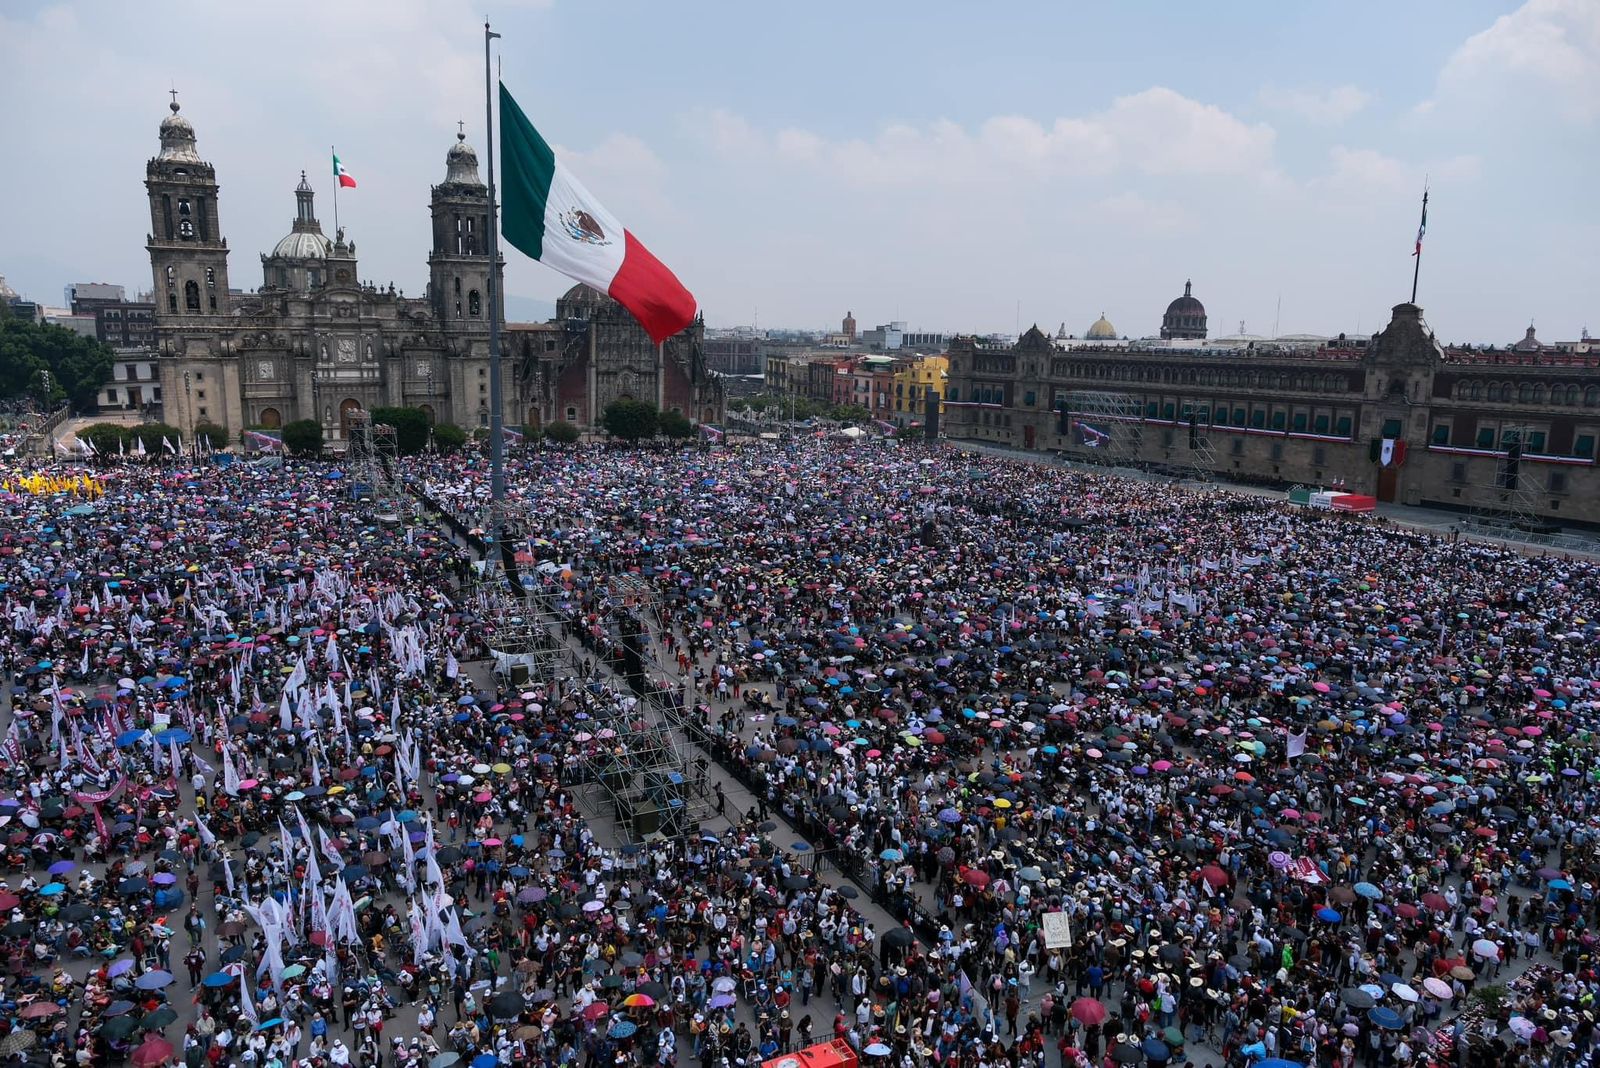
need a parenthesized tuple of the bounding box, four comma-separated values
(144, 91, 229, 326)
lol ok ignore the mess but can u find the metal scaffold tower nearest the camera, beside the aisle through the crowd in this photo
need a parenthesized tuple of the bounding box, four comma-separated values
(569, 574, 712, 841)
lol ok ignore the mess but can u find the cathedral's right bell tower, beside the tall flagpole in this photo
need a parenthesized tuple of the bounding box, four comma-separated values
(427, 131, 490, 331)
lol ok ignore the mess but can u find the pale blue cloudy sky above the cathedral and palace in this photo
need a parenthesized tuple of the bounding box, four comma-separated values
(0, 0, 1600, 341)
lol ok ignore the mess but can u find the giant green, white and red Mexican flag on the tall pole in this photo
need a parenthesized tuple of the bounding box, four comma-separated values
(501, 85, 694, 342)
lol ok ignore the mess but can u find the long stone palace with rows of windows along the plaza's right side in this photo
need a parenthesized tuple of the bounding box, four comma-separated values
(944, 288, 1600, 526)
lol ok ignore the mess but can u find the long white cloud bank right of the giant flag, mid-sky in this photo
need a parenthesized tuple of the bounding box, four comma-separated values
(696, 86, 1275, 185)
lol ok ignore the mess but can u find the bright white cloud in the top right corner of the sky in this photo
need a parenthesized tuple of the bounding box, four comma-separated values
(1438, 0, 1600, 120)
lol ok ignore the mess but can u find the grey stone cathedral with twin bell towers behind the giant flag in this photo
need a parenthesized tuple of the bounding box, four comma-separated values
(144, 92, 723, 446)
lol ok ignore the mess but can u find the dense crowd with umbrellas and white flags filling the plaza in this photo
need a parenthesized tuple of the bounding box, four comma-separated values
(0, 440, 1600, 1068)
